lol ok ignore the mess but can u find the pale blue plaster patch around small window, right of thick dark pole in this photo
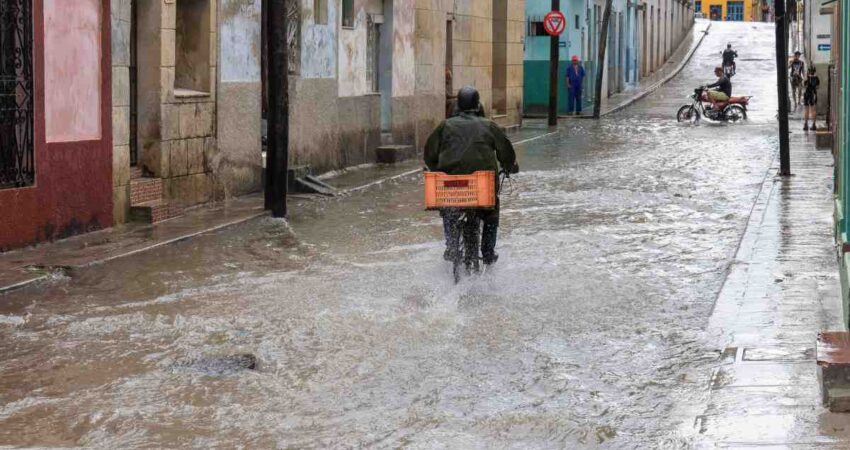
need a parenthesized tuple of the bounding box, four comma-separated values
(301, 0, 340, 79)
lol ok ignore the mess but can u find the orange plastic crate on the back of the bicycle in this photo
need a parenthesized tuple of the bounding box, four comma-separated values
(425, 170, 496, 209)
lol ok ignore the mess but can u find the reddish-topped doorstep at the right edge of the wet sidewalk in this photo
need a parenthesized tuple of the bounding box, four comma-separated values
(817, 331, 850, 412)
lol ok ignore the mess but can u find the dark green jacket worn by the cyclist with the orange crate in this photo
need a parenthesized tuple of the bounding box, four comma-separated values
(425, 112, 516, 175)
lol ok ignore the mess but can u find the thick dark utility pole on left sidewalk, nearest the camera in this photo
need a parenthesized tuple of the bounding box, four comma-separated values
(265, 0, 290, 217)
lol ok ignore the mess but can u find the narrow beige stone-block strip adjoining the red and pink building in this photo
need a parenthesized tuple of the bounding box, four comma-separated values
(111, 0, 133, 225)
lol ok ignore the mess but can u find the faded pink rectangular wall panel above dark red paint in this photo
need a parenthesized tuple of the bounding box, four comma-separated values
(44, 0, 102, 142)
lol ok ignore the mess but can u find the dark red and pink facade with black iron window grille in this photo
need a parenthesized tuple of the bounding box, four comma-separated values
(0, 0, 112, 251)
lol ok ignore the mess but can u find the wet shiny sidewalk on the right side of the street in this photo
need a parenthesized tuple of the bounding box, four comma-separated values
(694, 126, 850, 448)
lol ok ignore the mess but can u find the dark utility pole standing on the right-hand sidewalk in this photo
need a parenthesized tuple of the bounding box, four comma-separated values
(774, 0, 791, 177)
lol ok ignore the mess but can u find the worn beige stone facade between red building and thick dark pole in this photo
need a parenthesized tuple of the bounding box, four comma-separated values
(112, 0, 262, 223)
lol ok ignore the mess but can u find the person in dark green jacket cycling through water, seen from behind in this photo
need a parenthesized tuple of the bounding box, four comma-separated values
(425, 86, 519, 265)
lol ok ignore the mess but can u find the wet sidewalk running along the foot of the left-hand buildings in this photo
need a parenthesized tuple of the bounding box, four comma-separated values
(0, 124, 557, 294)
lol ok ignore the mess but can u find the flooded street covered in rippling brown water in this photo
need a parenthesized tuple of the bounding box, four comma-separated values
(0, 23, 777, 449)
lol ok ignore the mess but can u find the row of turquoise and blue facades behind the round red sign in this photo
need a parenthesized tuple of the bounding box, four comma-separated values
(524, 0, 694, 115)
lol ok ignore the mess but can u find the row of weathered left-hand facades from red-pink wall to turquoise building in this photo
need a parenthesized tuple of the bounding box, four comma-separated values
(0, 0, 524, 251)
